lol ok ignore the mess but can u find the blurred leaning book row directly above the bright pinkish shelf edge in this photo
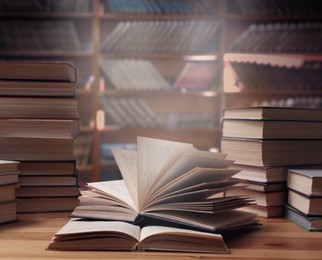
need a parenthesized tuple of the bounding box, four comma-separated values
(229, 22, 322, 53)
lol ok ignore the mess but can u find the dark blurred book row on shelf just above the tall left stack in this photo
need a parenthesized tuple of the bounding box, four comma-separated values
(0, 19, 84, 51)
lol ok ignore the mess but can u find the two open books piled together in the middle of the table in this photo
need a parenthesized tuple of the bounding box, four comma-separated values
(48, 137, 259, 253)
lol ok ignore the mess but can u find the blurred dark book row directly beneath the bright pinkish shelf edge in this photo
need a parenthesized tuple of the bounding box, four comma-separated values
(226, 61, 322, 91)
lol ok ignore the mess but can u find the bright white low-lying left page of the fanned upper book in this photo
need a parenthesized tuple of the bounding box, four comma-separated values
(88, 180, 138, 211)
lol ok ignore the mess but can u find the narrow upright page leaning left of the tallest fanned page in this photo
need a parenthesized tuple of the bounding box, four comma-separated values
(112, 148, 138, 208)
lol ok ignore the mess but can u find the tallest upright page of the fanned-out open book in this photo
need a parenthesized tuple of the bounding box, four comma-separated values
(137, 137, 193, 208)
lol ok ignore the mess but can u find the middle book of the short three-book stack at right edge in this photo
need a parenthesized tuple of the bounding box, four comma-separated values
(288, 188, 322, 216)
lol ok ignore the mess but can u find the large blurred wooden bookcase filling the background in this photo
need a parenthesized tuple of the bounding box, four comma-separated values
(0, 0, 322, 182)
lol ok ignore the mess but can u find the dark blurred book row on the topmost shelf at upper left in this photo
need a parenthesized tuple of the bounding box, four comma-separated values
(0, 0, 92, 13)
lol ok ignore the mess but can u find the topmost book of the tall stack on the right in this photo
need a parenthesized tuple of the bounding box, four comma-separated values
(222, 106, 322, 121)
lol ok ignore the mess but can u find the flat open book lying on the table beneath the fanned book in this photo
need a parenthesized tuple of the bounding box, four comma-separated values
(47, 219, 228, 253)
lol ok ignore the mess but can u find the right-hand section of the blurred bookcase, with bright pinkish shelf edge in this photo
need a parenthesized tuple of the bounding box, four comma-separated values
(222, 0, 322, 107)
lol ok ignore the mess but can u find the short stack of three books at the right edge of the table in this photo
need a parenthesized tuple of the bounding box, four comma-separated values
(285, 169, 322, 231)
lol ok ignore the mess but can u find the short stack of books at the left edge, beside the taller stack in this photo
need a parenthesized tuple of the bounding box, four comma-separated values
(0, 160, 19, 224)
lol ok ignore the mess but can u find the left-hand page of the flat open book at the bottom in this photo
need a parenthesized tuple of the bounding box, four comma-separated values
(55, 219, 140, 241)
